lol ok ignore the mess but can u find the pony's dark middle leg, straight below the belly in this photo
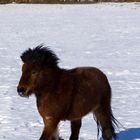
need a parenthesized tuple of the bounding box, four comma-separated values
(70, 119, 82, 140)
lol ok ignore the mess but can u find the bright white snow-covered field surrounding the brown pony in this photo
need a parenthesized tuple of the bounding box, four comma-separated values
(0, 3, 140, 140)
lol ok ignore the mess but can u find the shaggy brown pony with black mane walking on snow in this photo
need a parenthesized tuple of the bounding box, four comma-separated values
(17, 45, 117, 140)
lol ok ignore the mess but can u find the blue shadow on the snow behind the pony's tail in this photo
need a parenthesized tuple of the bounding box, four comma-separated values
(100, 128, 140, 140)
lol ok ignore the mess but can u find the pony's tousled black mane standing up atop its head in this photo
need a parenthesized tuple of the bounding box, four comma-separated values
(21, 44, 59, 66)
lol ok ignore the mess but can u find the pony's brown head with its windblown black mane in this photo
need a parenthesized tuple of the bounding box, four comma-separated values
(17, 45, 59, 97)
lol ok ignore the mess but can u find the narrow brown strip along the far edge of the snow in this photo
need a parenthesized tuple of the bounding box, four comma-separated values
(0, 0, 140, 4)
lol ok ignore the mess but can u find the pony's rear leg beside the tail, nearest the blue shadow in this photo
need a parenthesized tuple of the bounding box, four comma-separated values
(94, 109, 116, 140)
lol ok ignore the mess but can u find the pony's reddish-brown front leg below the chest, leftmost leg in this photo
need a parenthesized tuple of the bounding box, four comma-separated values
(39, 117, 59, 140)
